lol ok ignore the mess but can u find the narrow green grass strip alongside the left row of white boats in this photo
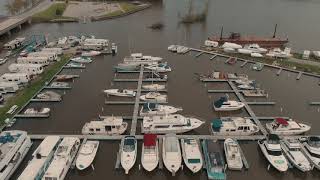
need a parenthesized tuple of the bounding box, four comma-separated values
(0, 55, 69, 126)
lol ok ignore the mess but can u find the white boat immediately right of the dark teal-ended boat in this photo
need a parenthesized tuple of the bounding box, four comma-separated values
(224, 138, 243, 171)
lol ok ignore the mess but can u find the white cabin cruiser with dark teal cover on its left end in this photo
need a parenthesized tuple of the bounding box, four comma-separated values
(211, 117, 259, 136)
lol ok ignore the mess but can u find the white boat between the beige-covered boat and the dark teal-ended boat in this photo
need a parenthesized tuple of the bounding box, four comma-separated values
(181, 138, 203, 173)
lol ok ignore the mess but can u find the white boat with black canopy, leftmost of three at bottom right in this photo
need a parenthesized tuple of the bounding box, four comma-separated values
(258, 134, 288, 172)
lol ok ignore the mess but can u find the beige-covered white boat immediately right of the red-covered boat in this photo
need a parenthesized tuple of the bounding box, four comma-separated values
(162, 134, 182, 175)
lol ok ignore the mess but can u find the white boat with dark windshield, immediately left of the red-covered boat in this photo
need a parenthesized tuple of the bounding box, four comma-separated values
(120, 136, 137, 174)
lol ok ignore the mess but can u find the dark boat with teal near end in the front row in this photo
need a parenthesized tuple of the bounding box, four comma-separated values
(202, 139, 227, 180)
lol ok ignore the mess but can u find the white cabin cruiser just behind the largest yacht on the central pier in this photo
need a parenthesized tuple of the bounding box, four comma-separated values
(140, 103, 182, 116)
